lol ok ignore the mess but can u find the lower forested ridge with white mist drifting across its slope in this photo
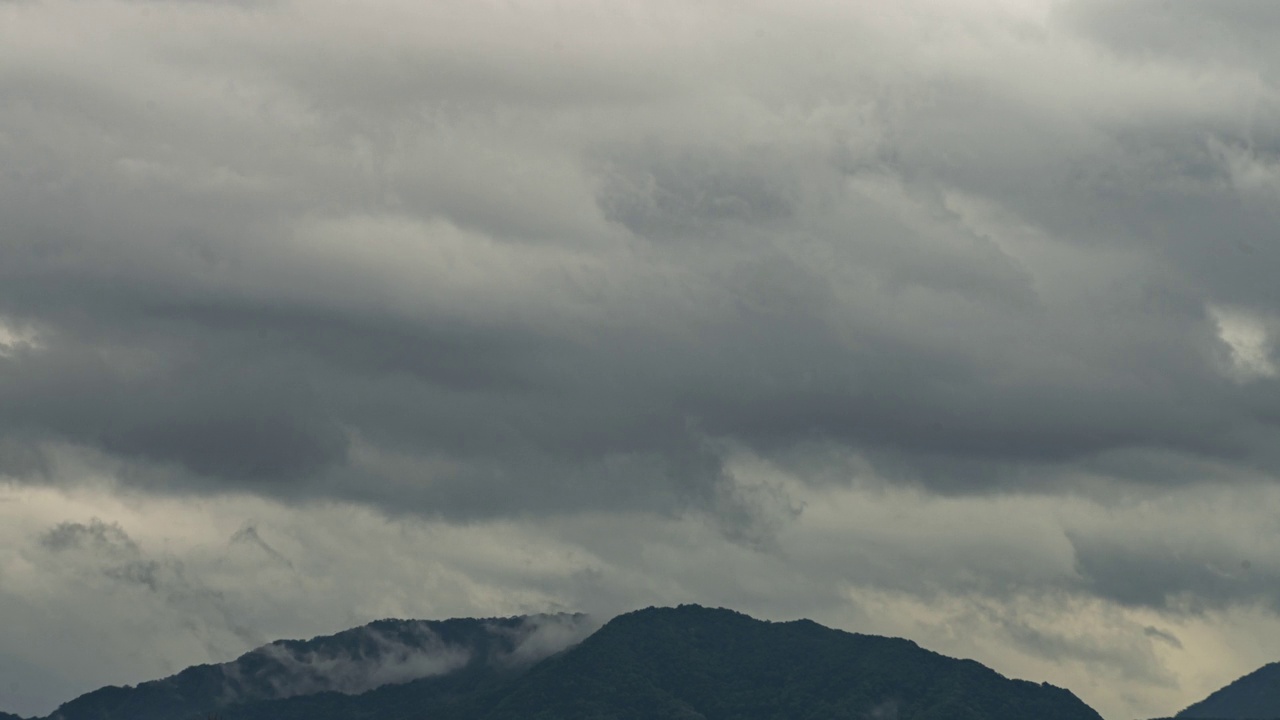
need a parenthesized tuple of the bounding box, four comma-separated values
(47, 615, 594, 720)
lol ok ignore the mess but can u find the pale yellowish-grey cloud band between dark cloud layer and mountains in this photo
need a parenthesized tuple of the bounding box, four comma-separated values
(0, 476, 1280, 716)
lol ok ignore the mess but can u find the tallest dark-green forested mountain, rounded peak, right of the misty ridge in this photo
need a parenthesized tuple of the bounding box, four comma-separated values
(477, 606, 1100, 720)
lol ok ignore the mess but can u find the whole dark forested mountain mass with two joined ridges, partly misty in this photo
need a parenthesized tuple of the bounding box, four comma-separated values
(15, 605, 1101, 720)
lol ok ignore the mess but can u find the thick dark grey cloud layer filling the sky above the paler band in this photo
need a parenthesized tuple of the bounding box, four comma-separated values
(0, 3, 1280, 630)
